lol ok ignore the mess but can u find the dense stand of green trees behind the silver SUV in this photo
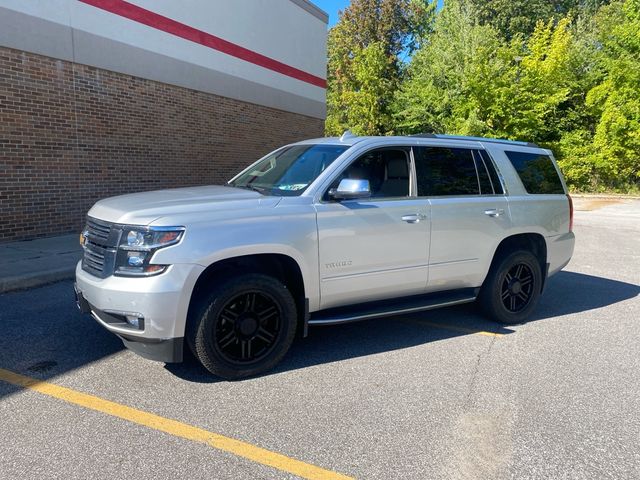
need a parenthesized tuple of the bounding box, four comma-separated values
(327, 0, 640, 192)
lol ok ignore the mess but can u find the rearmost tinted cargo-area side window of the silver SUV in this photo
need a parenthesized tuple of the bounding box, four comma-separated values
(504, 152, 564, 194)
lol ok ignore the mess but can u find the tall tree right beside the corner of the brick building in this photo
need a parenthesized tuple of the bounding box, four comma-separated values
(325, 0, 435, 135)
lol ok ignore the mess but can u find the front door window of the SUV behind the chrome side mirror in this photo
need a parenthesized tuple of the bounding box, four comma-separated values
(325, 148, 409, 198)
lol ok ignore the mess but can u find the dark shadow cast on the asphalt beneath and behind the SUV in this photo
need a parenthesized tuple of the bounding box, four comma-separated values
(167, 272, 640, 382)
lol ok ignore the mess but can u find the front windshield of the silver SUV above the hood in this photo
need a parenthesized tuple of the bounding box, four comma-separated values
(229, 145, 349, 196)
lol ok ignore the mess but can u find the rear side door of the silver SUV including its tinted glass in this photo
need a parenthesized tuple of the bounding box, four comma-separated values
(414, 146, 511, 292)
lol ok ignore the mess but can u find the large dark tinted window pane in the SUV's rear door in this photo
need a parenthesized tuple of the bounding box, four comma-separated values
(414, 147, 480, 197)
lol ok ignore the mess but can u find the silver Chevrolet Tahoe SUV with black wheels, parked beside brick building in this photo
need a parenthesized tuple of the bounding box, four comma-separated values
(76, 133, 574, 379)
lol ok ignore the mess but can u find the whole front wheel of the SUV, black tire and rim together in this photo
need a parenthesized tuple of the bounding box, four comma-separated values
(187, 274, 298, 380)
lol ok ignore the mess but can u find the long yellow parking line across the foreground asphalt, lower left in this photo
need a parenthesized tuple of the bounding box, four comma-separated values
(0, 368, 352, 480)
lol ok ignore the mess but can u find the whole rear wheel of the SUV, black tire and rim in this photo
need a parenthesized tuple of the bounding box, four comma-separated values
(478, 250, 542, 325)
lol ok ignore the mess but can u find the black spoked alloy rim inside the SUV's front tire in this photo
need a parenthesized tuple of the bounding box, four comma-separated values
(214, 291, 282, 364)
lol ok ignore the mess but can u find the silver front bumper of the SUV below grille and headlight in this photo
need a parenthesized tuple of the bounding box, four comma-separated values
(75, 263, 204, 362)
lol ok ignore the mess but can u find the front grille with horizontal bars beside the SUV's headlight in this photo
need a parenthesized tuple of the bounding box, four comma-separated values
(82, 217, 121, 278)
